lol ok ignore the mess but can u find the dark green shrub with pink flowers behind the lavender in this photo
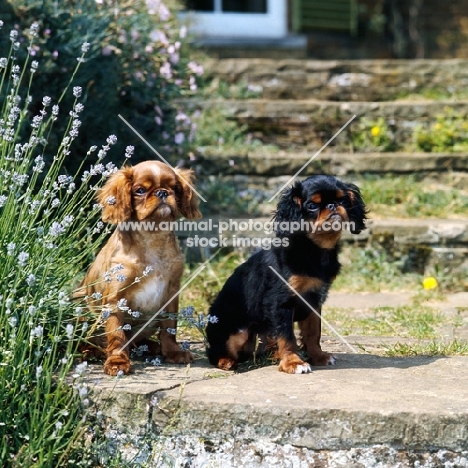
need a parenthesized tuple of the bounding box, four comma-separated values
(0, 0, 203, 171)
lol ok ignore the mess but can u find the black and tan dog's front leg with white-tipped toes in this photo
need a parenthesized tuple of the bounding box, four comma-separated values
(275, 308, 311, 374)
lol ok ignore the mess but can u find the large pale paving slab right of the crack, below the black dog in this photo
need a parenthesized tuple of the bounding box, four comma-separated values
(152, 355, 468, 451)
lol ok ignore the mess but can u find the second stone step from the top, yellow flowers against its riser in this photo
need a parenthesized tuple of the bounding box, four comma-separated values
(188, 99, 468, 151)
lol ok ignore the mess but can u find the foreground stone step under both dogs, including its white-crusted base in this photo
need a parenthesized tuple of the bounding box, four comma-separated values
(90, 354, 468, 460)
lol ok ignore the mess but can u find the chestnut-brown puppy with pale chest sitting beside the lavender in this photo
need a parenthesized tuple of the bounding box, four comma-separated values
(82, 161, 201, 375)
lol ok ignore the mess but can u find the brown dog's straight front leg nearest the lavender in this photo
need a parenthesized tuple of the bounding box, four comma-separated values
(104, 312, 131, 375)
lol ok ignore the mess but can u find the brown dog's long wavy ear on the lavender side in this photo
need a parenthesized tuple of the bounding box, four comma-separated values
(97, 167, 133, 224)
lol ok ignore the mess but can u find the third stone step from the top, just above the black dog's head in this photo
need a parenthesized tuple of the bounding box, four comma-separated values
(196, 149, 468, 176)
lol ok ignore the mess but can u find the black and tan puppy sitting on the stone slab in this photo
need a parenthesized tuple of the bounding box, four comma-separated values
(206, 175, 367, 374)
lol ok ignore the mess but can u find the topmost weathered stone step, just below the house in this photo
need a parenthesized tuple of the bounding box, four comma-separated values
(205, 59, 468, 101)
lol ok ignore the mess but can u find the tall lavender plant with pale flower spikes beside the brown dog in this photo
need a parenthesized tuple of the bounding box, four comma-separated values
(0, 23, 123, 467)
